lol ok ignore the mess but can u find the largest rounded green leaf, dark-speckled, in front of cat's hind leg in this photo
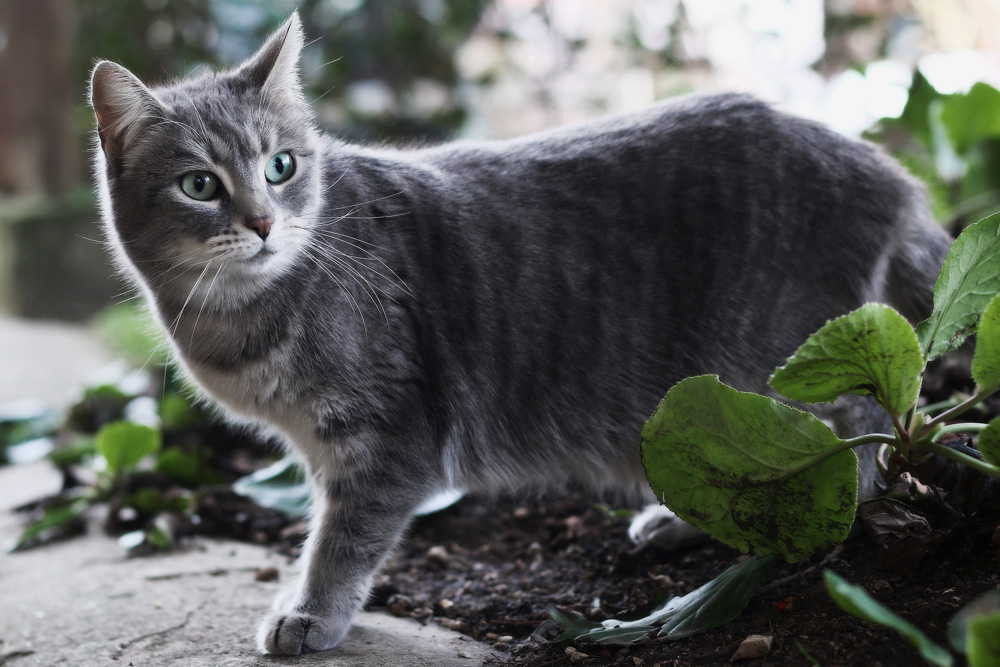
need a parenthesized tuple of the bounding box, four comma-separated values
(642, 375, 858, 561)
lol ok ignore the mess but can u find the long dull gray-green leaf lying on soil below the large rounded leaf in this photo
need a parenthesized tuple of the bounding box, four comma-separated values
(549, 556, 776, 644)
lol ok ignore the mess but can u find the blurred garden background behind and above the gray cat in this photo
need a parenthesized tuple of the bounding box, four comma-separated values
(0, 0, 1000, 402)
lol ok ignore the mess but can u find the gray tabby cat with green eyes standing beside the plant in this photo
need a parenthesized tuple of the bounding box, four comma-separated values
(91, 15, 949, 654)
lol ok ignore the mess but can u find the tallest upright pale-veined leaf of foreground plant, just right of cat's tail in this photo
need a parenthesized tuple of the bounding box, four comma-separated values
(917, 214, 1000, 361)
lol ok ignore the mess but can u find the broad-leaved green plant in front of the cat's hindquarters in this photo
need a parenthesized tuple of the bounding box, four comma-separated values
(642, 215, 1000, 561)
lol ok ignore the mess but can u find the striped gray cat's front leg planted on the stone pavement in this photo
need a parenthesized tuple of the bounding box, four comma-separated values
(257, 488, 412, 655)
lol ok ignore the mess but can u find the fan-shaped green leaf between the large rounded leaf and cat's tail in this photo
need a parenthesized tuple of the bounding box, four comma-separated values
(770, 303, 924, 415)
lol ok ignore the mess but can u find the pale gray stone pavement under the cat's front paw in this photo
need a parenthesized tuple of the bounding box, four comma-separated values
(0, 318, 500, 667)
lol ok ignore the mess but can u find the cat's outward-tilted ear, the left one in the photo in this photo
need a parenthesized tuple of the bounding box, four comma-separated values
(90, 60, 165, 158)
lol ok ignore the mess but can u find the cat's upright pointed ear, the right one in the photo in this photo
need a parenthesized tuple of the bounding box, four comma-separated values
(237, 12, 305, 104)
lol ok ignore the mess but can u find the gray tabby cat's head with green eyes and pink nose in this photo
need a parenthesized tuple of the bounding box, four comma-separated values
(90, 14, 320, 305)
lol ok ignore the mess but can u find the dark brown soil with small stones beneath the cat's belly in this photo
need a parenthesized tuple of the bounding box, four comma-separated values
(369, 488, 1000, 667)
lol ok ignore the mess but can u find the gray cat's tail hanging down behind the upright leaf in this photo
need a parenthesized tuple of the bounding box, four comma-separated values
(885, 202, 954, 324)
